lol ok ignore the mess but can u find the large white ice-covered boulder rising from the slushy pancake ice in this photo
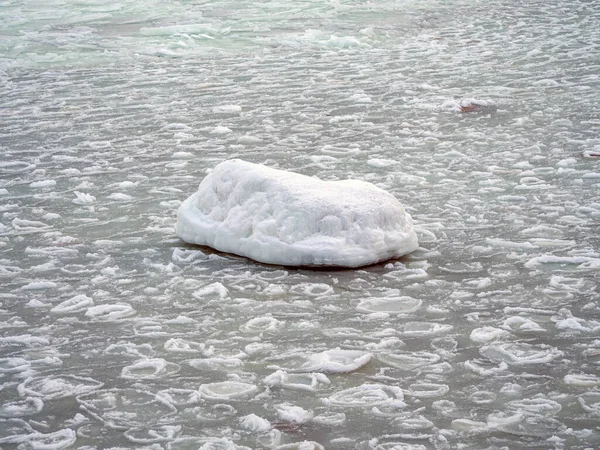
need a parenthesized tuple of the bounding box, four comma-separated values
(175, 159, 418, 267)
